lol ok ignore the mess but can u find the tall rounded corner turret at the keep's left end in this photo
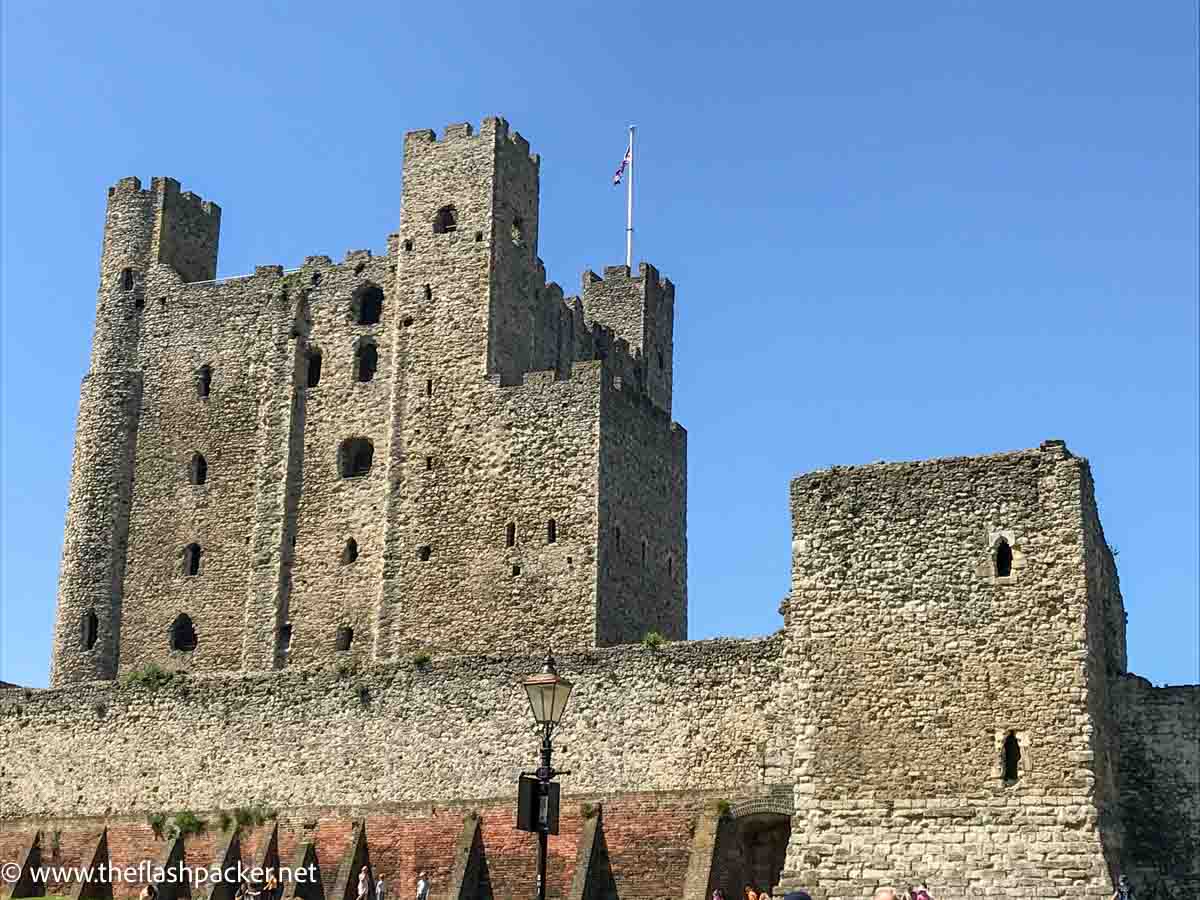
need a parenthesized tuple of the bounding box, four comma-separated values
(50, 178, 221, 685)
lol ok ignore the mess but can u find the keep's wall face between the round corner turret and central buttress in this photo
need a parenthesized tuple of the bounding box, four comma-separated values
(120, 265, 290, 672)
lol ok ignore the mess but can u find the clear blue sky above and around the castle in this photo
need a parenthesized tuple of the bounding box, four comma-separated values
(0, 0, 1200, 685)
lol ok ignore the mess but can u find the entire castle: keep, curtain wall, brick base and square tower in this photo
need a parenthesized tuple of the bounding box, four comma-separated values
(0, 119, 1200, 900)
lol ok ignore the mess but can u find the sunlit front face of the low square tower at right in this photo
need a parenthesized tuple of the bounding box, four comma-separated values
(785, 442, 1112, 898)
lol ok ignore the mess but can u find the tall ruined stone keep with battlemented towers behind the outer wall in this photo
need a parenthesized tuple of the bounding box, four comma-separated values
(52, 119, 686, 685)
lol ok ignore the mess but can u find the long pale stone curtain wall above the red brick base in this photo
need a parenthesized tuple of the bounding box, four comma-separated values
(0, 638, 780, 818)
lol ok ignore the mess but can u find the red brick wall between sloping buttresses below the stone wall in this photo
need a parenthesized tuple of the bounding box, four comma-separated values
(0, 793, 734, 900)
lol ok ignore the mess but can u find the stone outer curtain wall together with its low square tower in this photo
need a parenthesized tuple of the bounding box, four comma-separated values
(0, 442, 1200, 900)
